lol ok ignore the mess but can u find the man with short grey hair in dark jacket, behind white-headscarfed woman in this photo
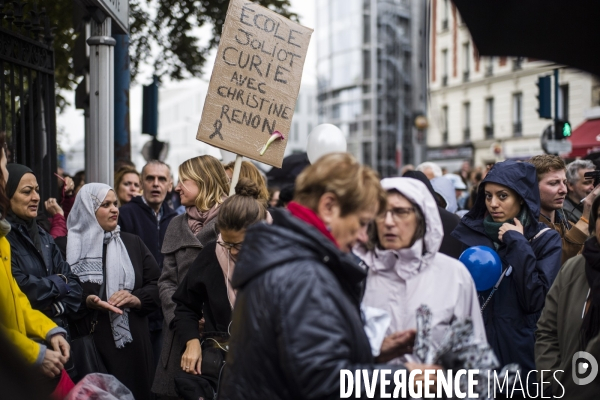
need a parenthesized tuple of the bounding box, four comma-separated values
(119, 160, 177, 364)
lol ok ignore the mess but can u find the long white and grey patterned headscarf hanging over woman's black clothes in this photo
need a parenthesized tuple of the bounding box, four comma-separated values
(67, 183, 135, 349)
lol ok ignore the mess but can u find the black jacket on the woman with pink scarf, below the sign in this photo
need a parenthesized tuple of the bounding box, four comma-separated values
(171, 242, 234, 350)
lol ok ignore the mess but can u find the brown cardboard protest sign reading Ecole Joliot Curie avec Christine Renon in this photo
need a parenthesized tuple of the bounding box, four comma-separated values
(196, 0, 313, 167)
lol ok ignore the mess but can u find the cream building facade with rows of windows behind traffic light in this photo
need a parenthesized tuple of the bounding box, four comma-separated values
(425, 0, 598, 171)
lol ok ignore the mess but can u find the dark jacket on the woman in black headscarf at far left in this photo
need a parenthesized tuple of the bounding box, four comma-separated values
(6, 222, 82, 317)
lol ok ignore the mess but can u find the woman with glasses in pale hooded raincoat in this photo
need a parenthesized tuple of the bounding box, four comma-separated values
(354, 178, 486, 361)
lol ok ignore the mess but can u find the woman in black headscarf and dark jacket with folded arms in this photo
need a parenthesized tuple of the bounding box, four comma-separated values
(6, 164, 82, 327)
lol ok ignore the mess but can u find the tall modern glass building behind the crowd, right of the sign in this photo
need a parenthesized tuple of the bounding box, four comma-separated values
(315, 0, 427, 176)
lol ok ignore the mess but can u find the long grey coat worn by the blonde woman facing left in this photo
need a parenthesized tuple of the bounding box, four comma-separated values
(152, 214, 218, 396)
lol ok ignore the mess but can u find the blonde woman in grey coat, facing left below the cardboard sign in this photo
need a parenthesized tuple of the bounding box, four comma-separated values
(152, 155, 229, 399)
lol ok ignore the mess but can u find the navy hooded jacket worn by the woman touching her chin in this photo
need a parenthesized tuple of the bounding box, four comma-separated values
(452, 161, 562, 372)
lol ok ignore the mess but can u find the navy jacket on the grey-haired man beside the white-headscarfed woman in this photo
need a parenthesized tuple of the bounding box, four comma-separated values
(119, 196, 177, 270)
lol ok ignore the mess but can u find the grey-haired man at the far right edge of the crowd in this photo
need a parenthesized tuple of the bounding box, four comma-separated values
(563, 160, 596, 224)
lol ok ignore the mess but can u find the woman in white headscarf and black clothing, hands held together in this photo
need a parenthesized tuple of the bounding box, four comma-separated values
(67, 183, 160, 399)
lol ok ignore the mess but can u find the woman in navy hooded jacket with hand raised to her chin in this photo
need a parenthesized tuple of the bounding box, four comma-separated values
(452, 161, 562, 390)
